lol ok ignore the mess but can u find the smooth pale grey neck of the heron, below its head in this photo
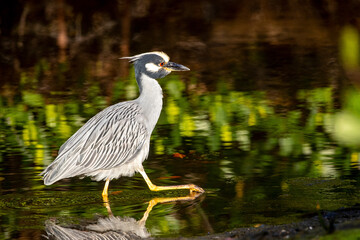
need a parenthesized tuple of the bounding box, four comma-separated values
(135, 74, 163, 134)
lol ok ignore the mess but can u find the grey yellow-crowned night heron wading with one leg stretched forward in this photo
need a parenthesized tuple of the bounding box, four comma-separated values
(41, 52, 204, 201)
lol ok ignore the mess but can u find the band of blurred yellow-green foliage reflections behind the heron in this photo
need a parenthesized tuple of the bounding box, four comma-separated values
(0, 67, 360, 182)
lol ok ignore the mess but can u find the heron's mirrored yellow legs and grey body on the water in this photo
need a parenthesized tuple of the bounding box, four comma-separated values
(45, 192, 204, 240)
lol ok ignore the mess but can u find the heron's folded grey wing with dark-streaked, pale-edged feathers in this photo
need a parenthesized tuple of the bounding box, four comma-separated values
(41, 101, 149, 185)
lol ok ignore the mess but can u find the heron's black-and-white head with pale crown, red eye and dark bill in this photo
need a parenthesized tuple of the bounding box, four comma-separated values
(120, 52, 190, 79)
